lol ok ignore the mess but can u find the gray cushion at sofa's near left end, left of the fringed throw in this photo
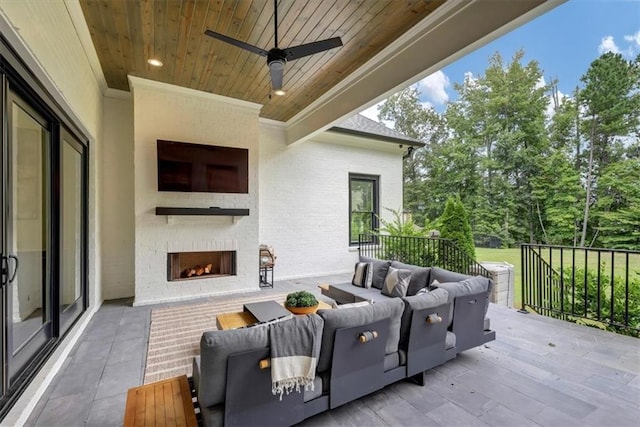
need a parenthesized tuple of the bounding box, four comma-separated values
(198, 325, 269, 407)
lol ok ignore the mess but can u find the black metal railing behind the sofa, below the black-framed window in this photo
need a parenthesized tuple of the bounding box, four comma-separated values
(358, 234, 491, 278)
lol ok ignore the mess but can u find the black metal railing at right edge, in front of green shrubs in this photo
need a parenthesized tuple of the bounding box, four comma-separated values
(521, 244, 640, 336)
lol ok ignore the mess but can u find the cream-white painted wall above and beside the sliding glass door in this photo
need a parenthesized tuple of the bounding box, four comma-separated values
(0, 0, 102, 306)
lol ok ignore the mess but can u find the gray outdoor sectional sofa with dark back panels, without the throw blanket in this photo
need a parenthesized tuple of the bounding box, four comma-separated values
(193, 260, 495, 426)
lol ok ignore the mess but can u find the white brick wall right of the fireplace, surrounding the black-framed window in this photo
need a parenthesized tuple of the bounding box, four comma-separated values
(260, 124, 406, 279)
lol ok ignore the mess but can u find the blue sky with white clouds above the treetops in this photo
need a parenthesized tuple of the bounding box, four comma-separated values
(363, 0, 640, 120)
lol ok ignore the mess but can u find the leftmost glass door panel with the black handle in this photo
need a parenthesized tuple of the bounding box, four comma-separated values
(5, 92, 52, 381)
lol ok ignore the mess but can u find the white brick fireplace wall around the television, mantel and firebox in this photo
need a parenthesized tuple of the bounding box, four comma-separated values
(131, 78, 259, 305)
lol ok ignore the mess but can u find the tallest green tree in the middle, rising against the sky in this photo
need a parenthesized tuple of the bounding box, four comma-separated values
(446, 51, 548, 243)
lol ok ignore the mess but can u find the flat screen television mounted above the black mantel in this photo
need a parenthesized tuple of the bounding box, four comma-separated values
(157, 139, 249, 193)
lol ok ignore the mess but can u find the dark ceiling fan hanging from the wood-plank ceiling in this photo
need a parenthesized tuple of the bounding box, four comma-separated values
(204, 0, 342, 95)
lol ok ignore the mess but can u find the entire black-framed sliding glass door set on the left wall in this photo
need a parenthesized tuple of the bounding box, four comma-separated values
(0, 47, 88, 419)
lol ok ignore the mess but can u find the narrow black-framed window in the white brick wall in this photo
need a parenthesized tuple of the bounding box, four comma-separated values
(349, 173, 380, 245)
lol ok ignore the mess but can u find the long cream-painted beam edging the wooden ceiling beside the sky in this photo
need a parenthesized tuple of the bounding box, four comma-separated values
(286, 0, 566, 144)
